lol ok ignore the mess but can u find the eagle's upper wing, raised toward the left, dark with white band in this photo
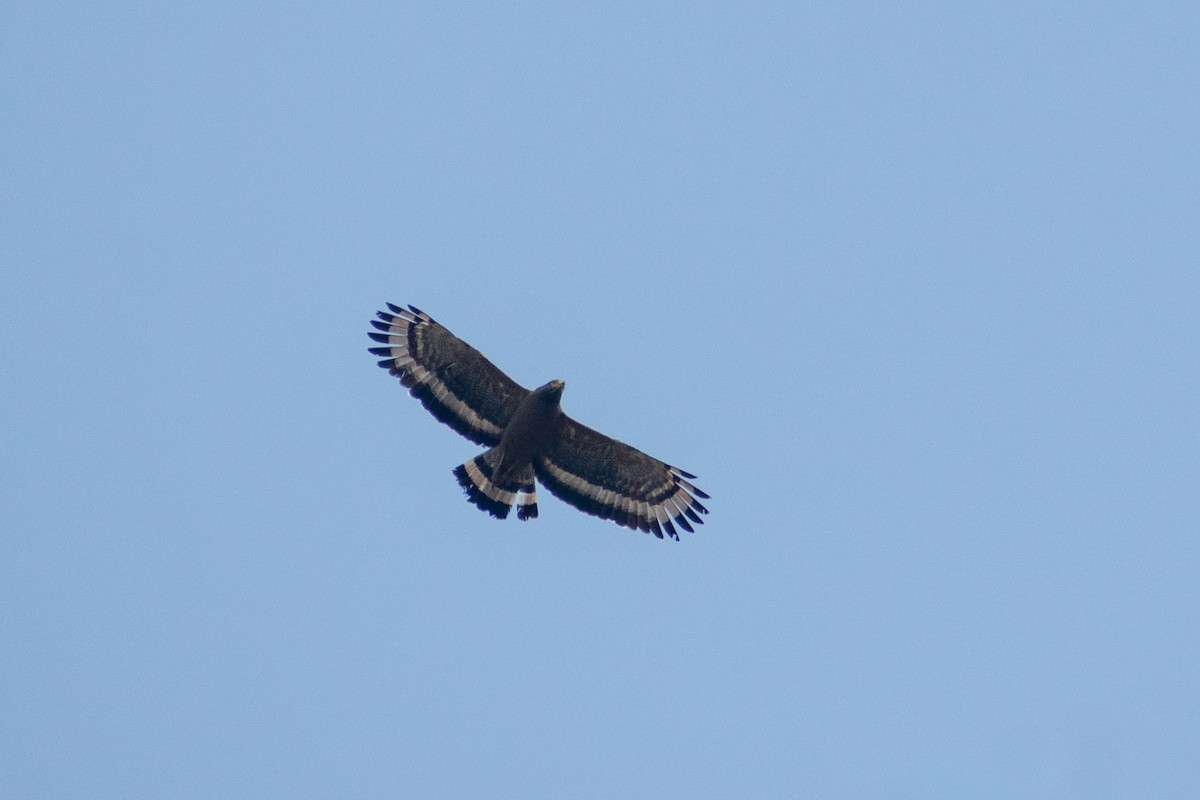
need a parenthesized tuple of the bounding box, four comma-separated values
(371, 303, 529, 447)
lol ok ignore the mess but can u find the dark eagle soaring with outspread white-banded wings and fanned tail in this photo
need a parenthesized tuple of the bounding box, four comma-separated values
(368, 302, 708, 540)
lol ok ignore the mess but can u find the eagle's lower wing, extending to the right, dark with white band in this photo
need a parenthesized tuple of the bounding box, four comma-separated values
(534, 416, 708, 539)
